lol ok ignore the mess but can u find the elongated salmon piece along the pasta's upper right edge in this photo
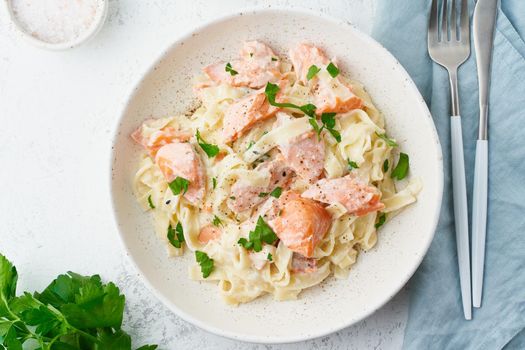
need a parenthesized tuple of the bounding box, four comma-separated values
(290, 44, 363, 115)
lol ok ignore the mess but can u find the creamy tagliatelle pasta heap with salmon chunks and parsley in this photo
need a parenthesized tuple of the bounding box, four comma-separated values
(133, 42, 422, 304)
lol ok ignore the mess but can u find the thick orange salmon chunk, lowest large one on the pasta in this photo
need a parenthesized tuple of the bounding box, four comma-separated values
(269, 197, 332, 257)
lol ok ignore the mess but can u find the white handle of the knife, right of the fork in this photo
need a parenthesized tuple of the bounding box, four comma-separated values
(472, 140, 489, 307)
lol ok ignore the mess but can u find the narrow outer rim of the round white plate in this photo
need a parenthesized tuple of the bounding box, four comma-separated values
(109, 5, 444, 344)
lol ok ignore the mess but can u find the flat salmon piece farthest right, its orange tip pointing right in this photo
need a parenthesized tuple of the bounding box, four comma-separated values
(301, 175, 385, 216)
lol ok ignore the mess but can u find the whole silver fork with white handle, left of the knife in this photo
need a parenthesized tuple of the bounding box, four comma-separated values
(428, 0, 472, 320)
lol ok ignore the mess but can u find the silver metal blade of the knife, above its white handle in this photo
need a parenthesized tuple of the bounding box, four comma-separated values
(472, 0, 498, 140)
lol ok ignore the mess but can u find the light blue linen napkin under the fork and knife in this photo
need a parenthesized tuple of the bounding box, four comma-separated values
(373, 0, 525, 350)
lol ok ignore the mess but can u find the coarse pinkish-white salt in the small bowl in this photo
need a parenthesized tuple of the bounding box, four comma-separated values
(11, 0, 104, 44)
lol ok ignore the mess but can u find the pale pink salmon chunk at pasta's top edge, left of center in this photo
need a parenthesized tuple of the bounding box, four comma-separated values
(204, 41, 281, 89)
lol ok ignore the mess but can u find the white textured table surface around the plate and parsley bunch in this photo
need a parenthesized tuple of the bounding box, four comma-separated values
(0, 0, 407, 350)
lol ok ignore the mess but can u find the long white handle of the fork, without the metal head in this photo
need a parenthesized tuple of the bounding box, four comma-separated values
(450, 115, 472, 320)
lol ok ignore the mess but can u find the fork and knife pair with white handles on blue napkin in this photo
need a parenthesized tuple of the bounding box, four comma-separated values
(428, 0, 498, 320)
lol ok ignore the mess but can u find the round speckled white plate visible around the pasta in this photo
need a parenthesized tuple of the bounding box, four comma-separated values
(111, 9, 443, 343)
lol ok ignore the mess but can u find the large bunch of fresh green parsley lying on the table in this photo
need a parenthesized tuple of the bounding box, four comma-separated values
(0, 254, 157, 350)
